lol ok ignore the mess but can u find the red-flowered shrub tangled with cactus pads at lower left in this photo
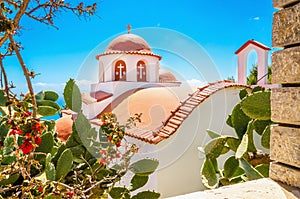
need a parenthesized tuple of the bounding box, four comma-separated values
(0, 80, 159, 198)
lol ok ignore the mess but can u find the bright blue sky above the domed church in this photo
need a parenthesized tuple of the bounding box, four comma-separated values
(5, 0, 275, 95)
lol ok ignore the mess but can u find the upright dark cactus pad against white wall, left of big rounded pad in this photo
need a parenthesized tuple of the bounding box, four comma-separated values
(231, 103, 251, 139)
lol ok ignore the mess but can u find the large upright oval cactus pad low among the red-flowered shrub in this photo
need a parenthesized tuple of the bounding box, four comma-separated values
(56, 149, 73, 180)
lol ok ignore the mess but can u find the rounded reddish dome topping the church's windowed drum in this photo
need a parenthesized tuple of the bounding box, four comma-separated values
(105, 34, 152, 53)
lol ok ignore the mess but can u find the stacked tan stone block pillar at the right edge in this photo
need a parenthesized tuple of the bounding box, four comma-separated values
(270, 0, 300, 188)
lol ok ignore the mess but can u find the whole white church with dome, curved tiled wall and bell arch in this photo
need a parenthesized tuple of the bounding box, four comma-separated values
(77, 26, 274, 198)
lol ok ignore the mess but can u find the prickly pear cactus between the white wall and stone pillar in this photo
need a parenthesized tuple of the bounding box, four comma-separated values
(201, 87, 272, 189)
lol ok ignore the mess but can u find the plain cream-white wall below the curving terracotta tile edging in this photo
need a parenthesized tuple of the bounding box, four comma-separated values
(126, 88, 244, 198)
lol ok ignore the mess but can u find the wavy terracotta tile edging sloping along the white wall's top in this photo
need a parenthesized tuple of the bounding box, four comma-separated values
(91, 80, 248, 144)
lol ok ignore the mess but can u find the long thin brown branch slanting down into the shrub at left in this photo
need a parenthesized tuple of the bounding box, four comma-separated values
(8, 34, 37, 118)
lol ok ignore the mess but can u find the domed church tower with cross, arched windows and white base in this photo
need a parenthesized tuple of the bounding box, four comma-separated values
(82, 25, 181, 119)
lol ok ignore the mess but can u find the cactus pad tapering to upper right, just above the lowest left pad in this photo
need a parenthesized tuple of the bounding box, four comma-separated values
(204, 137, 227, 159)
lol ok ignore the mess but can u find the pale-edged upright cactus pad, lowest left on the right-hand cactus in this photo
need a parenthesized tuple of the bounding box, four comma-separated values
(201, 158, 219, 189)
